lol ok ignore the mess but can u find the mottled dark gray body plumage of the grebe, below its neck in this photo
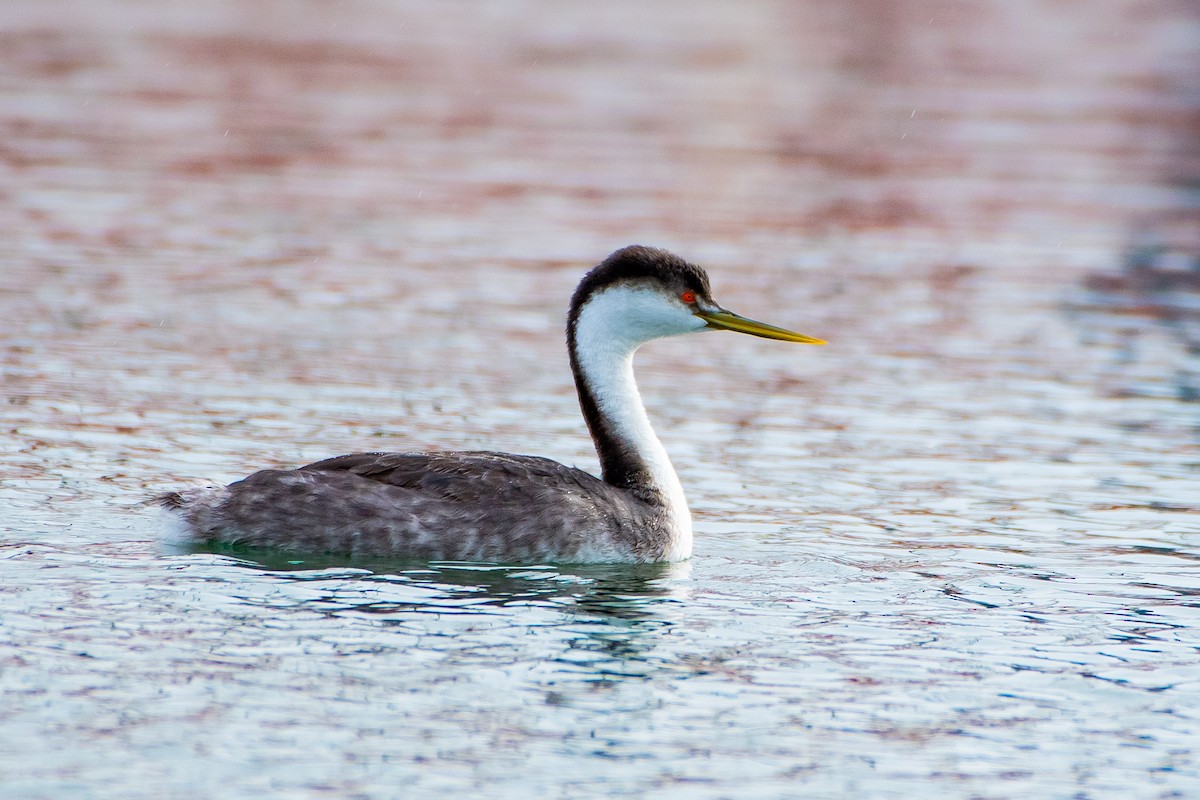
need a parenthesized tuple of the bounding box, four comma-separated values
(164, 452, 666, 563)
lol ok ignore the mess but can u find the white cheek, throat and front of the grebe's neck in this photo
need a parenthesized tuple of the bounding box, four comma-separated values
(575, 285, 706, 561)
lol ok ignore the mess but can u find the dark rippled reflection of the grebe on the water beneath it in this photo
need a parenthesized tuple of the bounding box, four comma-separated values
(181, 548, 691, 684)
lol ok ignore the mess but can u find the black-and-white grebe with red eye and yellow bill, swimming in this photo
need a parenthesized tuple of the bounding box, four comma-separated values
(157, 245, 824, 564)
